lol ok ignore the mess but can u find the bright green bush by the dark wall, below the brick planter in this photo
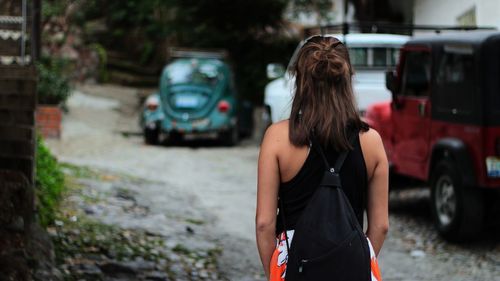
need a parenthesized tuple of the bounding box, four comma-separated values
(35, 137, 64, 226)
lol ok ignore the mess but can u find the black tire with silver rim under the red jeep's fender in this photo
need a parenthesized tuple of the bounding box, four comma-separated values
(431, 160, 484, 242)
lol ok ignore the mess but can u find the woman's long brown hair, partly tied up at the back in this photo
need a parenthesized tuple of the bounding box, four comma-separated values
(289, 36, 366, 151)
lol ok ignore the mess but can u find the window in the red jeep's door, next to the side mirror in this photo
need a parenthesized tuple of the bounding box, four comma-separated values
(402, 51, 431, 97)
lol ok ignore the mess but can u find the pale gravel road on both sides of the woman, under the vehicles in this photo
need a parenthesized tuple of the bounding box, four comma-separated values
(48, 85, 500, 281)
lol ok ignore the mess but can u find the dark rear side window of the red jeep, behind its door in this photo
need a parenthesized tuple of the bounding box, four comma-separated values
(436, 47, 476, 115)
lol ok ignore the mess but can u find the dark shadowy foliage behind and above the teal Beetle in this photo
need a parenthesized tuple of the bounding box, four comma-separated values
(53, 0, 332, 103)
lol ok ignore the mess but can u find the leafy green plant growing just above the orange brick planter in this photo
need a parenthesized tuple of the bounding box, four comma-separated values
(36, 60, 71, 105)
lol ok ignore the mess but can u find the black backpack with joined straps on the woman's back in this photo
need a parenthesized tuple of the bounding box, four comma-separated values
(280, 135, 371, 281)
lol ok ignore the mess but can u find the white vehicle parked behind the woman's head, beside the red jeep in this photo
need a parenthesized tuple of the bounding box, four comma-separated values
(263, 33, 410, 123)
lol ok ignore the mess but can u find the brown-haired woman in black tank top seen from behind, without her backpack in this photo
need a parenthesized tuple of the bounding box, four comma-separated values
(256, 36, 389, 281)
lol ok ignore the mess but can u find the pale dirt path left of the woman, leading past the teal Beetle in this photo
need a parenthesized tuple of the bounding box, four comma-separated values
(48, 83, 263, 281)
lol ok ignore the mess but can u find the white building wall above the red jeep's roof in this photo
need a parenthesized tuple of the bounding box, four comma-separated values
(414, 0, 500, 29)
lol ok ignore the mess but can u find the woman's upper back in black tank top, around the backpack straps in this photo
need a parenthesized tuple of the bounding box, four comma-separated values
(276, 121, 367, 233)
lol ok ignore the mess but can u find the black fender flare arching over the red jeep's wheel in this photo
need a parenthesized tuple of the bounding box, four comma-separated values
(428, 138, 477, 187)
